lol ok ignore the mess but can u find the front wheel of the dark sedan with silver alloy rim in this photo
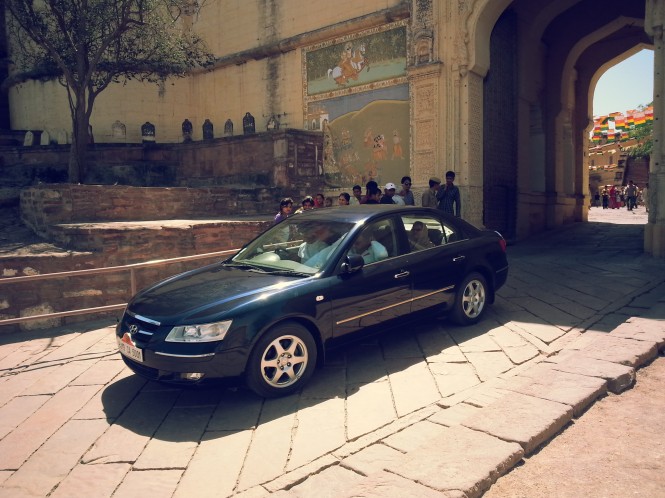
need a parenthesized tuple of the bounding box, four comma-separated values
(245, 323, 317, 398)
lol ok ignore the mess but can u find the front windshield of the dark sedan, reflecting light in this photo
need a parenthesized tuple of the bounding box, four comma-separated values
(230, 216, 353, 275)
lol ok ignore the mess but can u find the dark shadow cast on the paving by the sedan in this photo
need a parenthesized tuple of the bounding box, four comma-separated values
(101, 318, 496, 442)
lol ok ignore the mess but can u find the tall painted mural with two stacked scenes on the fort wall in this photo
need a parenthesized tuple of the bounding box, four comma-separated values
(303, 22, 410, 190)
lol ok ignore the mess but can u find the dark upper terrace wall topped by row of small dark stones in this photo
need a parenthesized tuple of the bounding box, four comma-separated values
(0, 129, 325, 190)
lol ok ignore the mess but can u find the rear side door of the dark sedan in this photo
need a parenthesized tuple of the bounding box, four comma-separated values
(401, 213, 466, 311)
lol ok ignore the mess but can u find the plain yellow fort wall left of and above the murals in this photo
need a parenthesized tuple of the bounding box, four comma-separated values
(9, 0, 410, 143)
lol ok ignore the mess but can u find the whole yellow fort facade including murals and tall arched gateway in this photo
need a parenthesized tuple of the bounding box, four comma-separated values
(9, 0, 665, 257)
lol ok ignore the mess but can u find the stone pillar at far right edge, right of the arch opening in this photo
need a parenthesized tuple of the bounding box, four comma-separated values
(644, 0, 665, 258)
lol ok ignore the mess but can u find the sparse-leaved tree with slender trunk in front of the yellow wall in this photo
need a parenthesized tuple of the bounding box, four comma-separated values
(3, 0, 213, 183)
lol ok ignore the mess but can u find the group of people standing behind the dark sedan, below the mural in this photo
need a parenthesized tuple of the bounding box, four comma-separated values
(275, 171, 462, 223)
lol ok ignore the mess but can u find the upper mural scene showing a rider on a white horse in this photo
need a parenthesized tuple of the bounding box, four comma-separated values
(305, 25, 406, 96)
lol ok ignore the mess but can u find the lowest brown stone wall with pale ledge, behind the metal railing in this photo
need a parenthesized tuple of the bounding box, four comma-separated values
(0, 217, 271, 334)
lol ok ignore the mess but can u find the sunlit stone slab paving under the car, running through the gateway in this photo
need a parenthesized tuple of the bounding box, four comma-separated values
(0, 204, 665, 498)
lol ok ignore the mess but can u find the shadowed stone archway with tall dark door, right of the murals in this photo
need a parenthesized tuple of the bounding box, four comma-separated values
(459, 0, 665, 247)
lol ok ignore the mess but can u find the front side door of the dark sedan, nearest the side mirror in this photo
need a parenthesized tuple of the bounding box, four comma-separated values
(331, 218, 412, 338)
